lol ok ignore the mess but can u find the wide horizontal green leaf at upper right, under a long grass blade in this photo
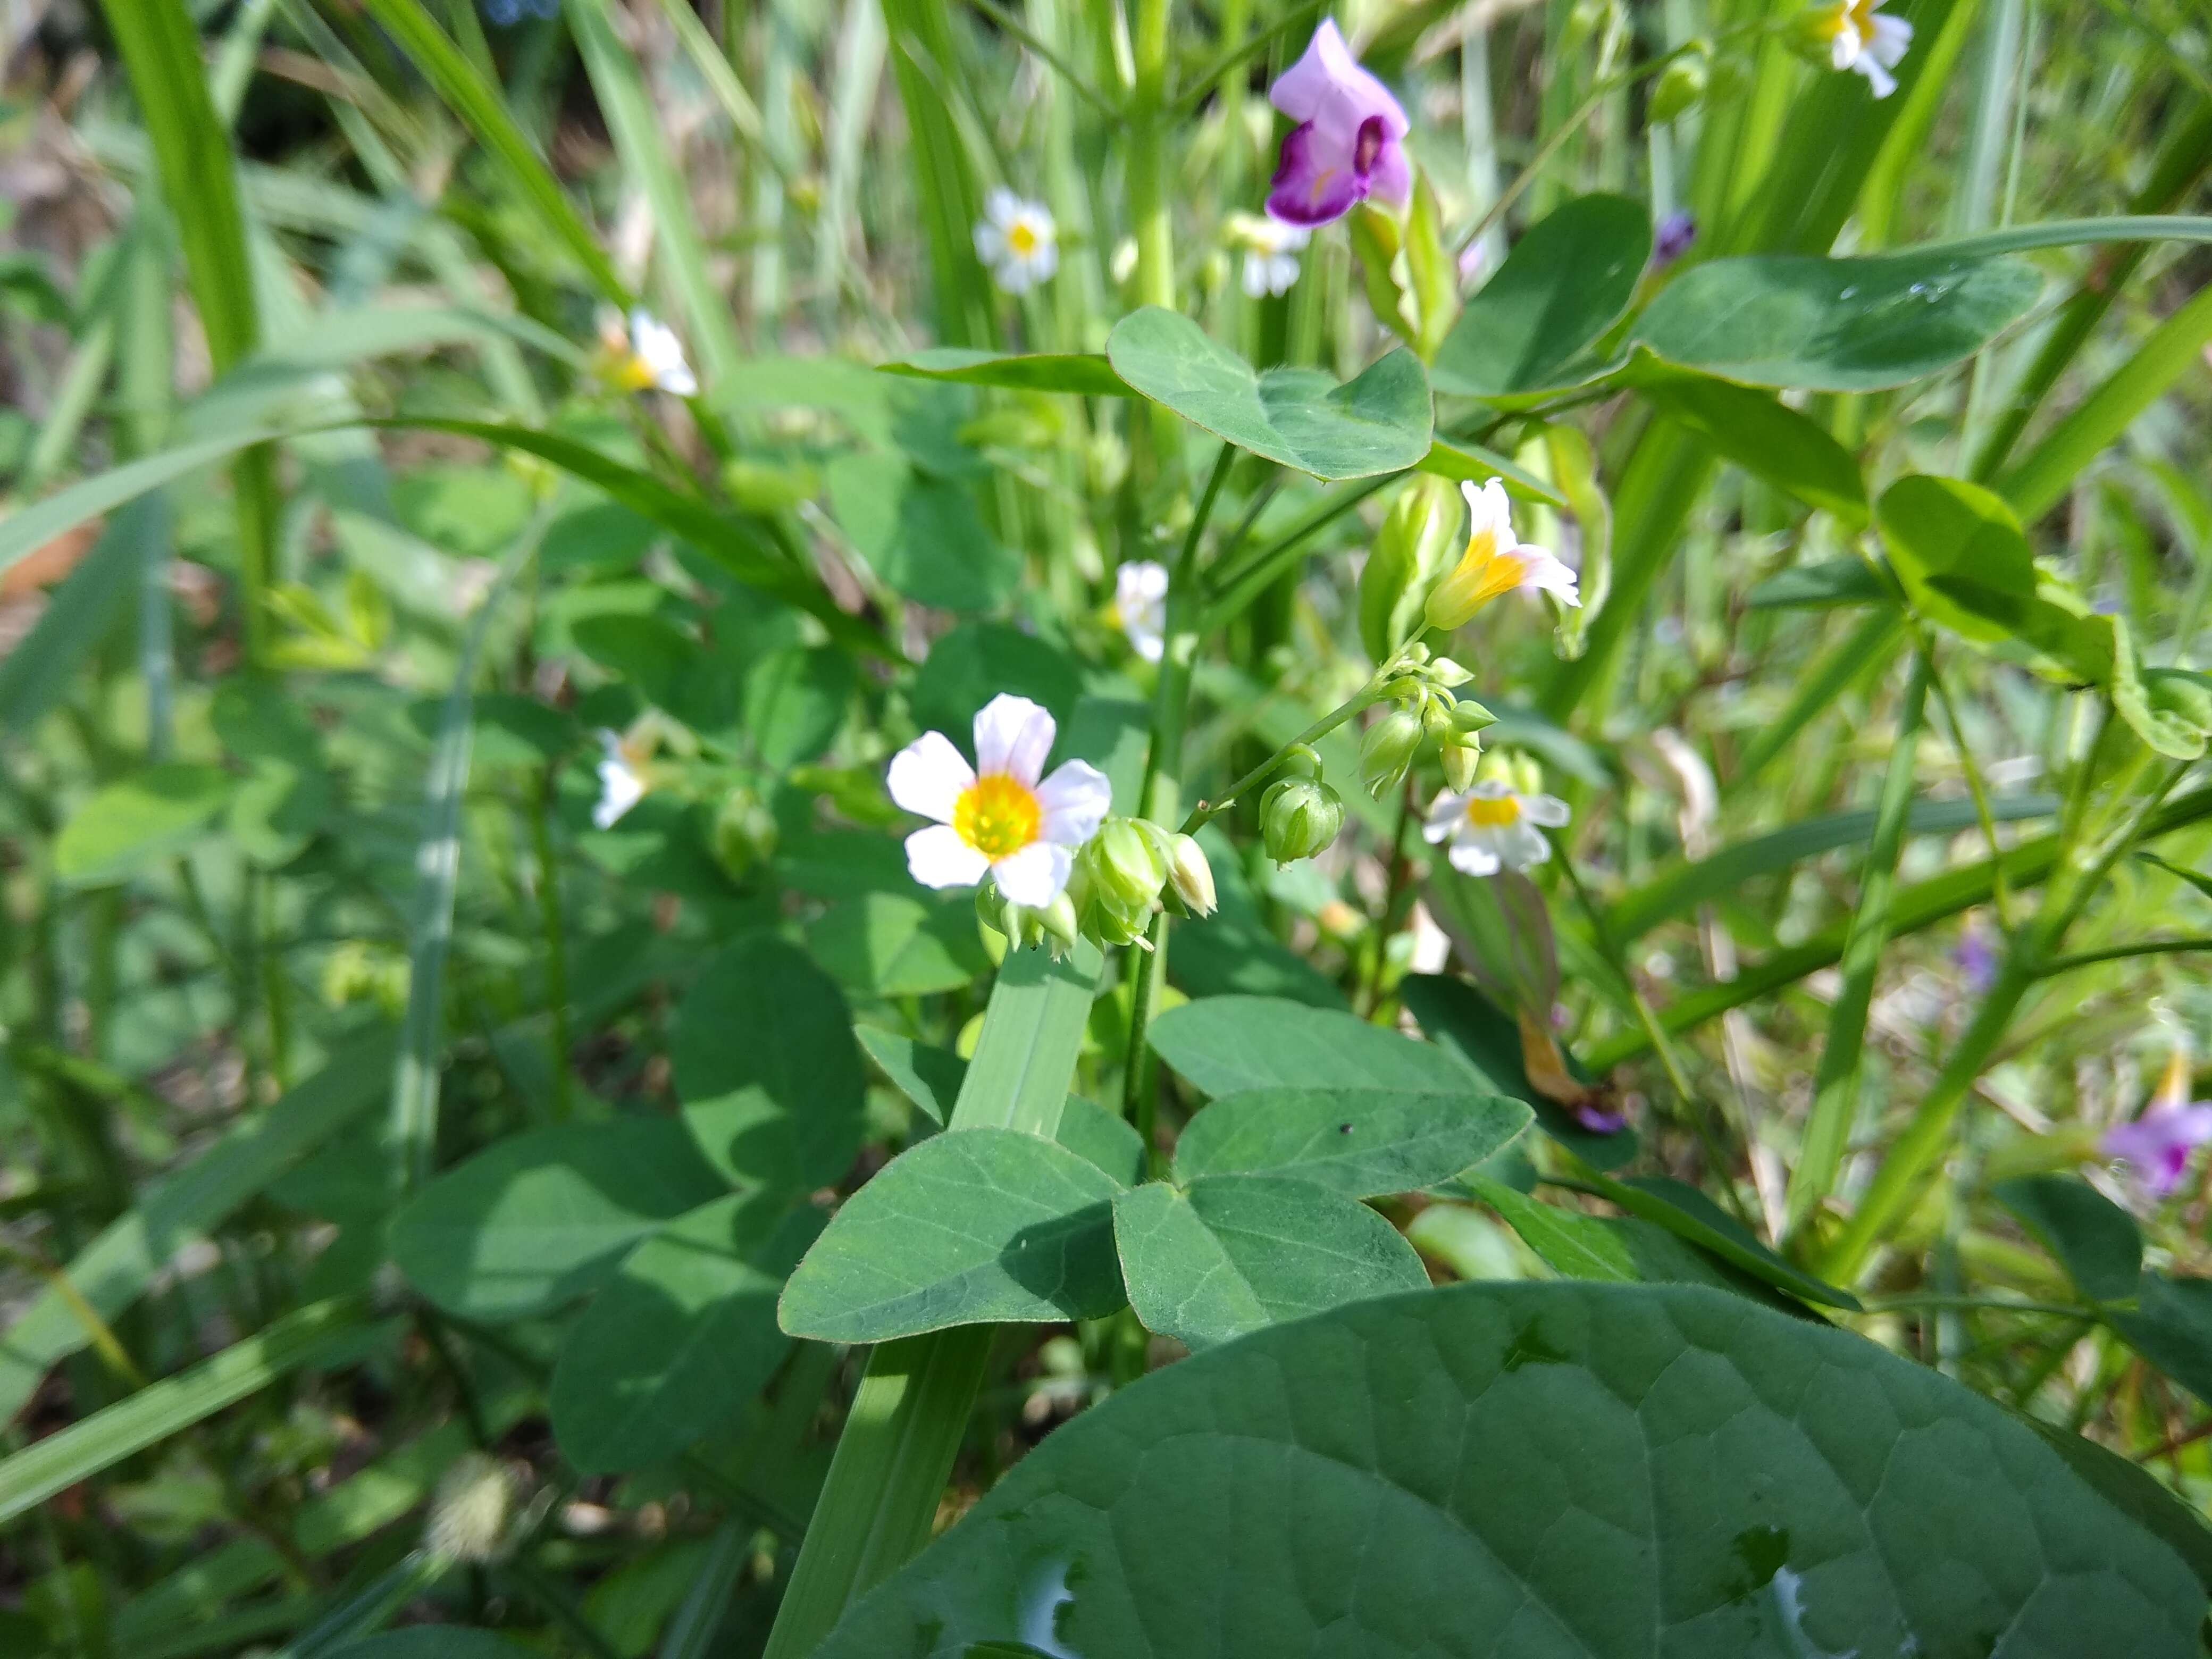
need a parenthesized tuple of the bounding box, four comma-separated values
(1632, 254, 2044, 391)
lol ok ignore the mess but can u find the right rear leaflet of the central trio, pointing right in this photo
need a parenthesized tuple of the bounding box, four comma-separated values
(1175, 1088, 1531, 1199)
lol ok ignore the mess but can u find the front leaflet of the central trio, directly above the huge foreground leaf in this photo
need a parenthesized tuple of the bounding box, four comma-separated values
(1112, 1175, 1429, 1347)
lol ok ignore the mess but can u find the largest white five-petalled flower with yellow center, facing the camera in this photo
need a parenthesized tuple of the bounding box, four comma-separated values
(889, 692, 1112, 909)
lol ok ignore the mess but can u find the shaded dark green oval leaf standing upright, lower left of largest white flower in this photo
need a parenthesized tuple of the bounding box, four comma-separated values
(670, 934, 867, 1192)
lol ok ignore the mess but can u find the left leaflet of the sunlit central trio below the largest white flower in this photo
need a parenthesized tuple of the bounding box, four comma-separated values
(778, 1128, 1124, 1343)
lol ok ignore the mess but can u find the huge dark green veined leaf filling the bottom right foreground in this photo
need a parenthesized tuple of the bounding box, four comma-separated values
(816, 1283, 2206, 1659)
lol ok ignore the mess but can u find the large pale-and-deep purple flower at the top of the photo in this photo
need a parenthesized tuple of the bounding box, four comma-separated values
(1268, 18, 1413, 225)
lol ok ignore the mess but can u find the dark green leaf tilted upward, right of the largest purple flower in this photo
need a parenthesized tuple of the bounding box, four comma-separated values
(1431, 195, 1653, 407)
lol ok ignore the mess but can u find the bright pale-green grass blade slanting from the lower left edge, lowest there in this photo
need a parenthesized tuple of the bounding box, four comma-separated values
(0, 1296, 367, 1522)
